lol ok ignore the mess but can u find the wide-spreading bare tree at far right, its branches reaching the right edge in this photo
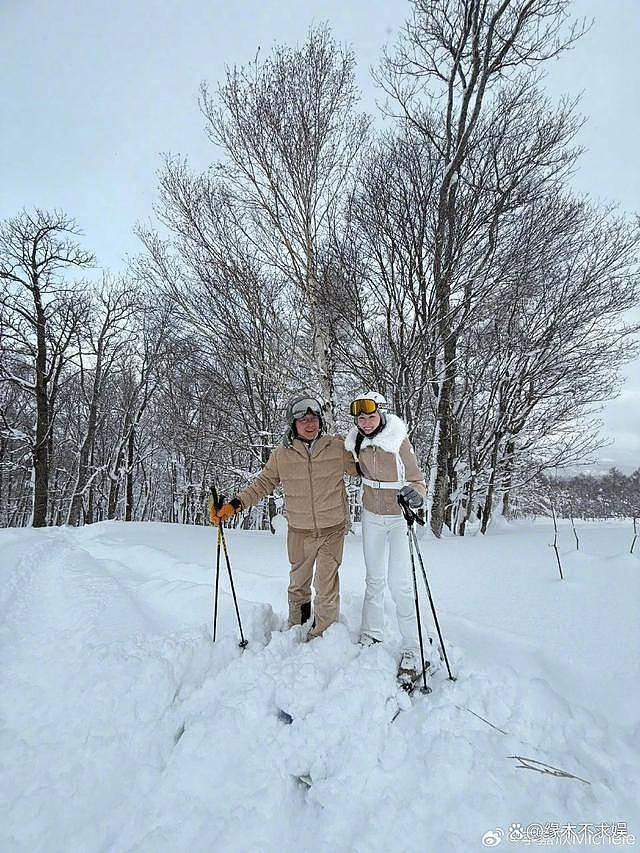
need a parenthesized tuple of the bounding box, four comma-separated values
(460, 193, 640, 532)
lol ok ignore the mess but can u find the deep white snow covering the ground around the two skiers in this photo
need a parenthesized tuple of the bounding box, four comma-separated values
(0, 522, 640, 853)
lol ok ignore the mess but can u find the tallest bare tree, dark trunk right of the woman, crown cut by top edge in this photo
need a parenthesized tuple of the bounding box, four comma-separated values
(378, 0, 580, 536)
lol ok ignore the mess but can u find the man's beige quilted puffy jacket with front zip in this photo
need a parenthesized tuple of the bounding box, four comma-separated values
(238, 435, 357, 530)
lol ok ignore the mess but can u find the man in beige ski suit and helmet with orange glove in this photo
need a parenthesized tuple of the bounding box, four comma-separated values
(211, 392, 358, 640)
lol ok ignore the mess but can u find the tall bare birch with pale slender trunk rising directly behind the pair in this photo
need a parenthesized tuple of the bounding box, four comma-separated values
(201, 28, 368, 428)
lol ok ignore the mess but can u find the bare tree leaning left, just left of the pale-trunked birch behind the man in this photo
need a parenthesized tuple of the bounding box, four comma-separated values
(137, 172, 300, 452)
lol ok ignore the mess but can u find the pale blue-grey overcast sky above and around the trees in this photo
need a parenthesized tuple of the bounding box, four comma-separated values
(0, 0, 640, 470)
